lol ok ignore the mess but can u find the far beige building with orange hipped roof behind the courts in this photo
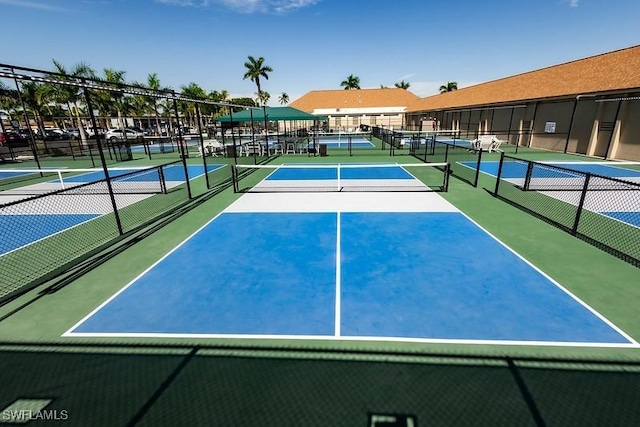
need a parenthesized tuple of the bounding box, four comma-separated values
(289, 88, 419, 131)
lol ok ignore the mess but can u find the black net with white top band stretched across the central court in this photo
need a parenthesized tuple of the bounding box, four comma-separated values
(233, 163, 449, 192)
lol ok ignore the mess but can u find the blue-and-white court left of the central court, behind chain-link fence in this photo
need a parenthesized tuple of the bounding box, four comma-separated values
(0, 164, 224, 256)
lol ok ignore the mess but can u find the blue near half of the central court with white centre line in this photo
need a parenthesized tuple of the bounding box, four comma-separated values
(65, 204, 638, 347)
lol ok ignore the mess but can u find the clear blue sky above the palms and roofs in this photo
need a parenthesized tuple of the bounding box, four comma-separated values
(0, 0, 640, 105)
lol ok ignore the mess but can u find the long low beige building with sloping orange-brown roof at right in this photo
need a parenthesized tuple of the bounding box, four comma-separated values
(406, 46, 640, 160)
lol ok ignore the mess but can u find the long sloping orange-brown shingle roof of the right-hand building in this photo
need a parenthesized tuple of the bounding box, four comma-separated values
(407, 46, 640, 112)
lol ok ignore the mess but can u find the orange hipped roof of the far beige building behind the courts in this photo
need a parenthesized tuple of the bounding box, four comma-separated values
(289, 88, 419, 113)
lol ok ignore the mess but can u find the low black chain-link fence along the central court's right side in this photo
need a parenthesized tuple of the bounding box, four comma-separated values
(493, 153, 640, 267)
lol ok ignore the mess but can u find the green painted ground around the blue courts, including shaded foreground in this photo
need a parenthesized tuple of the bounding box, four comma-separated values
(0, 141, 640, 426)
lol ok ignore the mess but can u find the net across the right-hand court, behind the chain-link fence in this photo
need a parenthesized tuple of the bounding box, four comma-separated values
(515, 162, 640, 191)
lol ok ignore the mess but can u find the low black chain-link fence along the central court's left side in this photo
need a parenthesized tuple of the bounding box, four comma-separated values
(0, 161, 198, 305)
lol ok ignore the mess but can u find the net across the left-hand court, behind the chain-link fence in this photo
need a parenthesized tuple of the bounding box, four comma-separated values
(0, 166, 166, 196)
